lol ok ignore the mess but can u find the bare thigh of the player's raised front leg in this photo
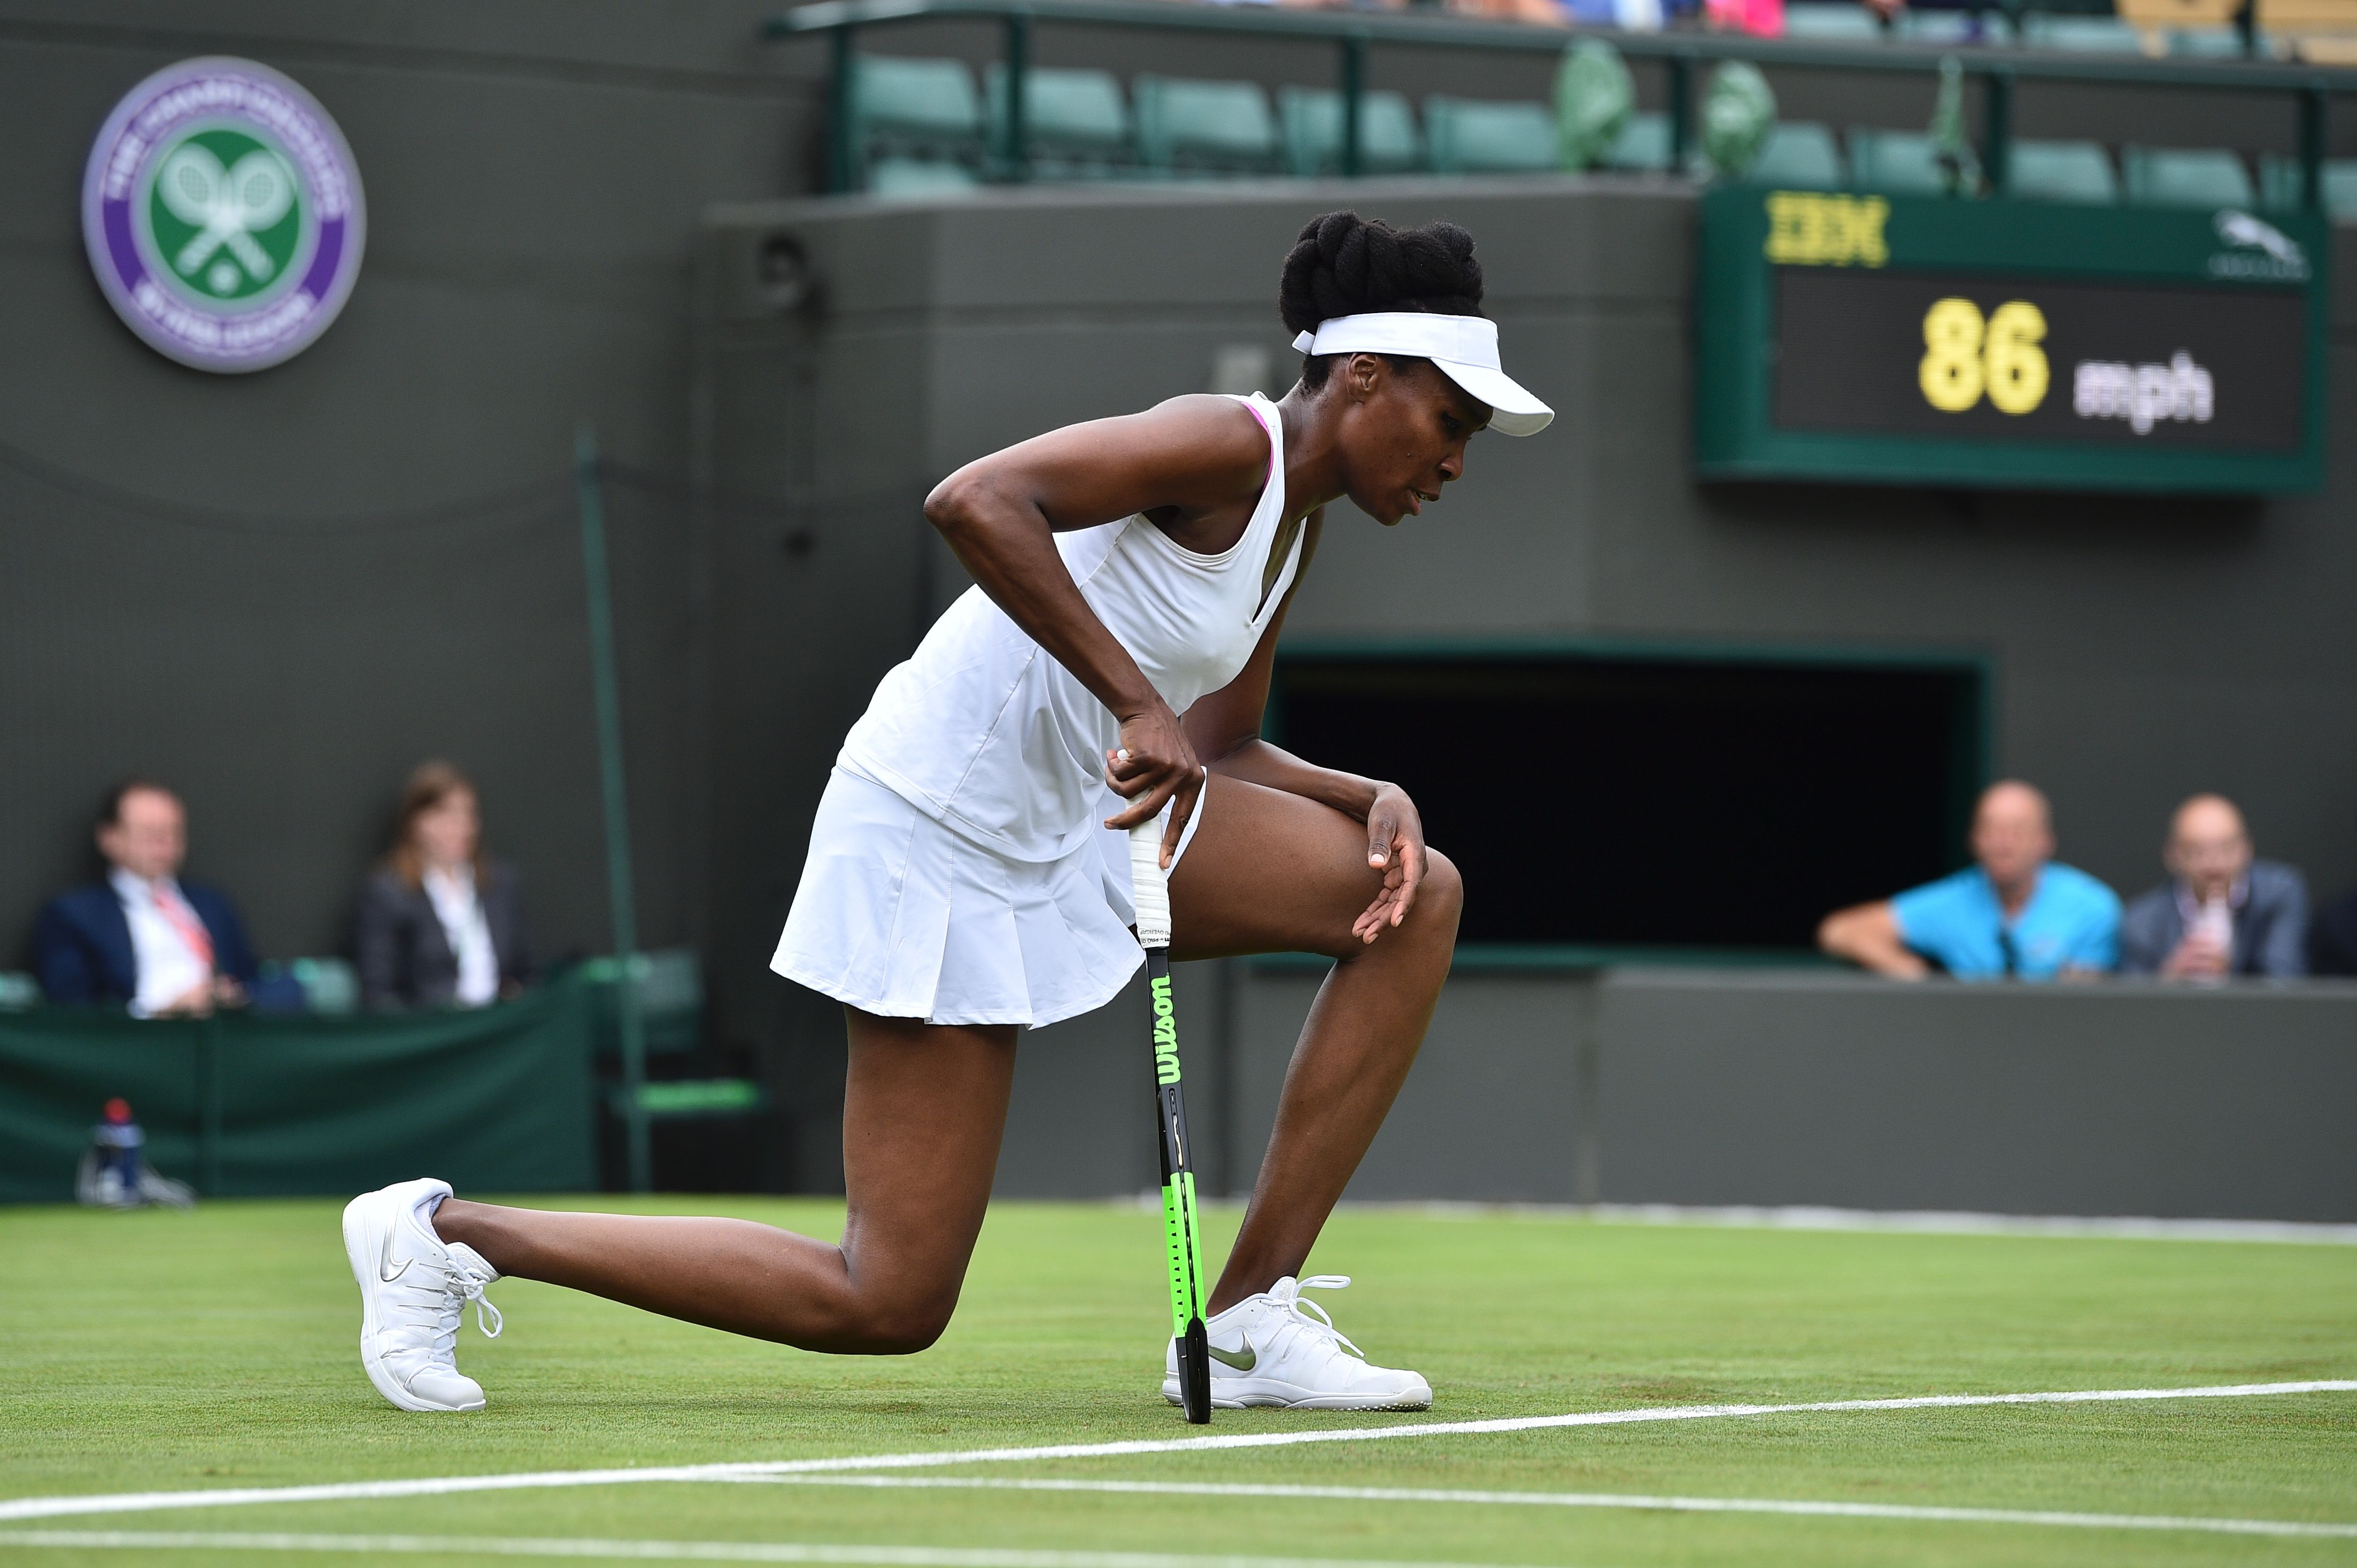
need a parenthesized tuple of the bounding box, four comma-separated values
(1171, 773, 1417, 960)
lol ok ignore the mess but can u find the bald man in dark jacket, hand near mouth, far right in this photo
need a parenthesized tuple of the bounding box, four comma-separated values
(2119, 795, 2307, 981)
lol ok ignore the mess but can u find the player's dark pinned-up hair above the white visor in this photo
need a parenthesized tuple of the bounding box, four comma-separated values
(1278, 212, 1480, 389)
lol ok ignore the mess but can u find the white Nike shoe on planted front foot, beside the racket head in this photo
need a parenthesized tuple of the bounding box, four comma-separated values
(1162, 1273, 1433, 1410)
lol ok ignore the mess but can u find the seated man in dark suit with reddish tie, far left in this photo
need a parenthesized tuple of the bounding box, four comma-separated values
(33, 778, 259, 1019)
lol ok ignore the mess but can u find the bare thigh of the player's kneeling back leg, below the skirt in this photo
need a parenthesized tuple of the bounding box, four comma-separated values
(844, 1007, 1016, 1301)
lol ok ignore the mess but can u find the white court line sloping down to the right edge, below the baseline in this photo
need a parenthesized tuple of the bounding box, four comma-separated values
(721, 1476, 2357, 1542)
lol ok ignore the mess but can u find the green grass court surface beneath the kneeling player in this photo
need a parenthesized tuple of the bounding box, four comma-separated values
(0, 1198, 2357, 1568)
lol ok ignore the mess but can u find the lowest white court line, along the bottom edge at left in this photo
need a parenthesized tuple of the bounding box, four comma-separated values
(0, 1530, 1489, 1568)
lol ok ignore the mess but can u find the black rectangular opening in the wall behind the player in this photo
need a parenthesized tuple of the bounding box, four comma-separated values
(1268, 651, 1987, 955)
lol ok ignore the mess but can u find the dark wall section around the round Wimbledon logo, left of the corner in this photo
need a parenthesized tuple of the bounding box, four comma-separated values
(0, 0, 829, 967)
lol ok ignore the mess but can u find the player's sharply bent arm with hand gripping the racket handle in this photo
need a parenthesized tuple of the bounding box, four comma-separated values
(924, 396, 1268, 860)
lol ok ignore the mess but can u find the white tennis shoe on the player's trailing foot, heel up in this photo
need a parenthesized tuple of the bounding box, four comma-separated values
(344, 1177, 500, 1410)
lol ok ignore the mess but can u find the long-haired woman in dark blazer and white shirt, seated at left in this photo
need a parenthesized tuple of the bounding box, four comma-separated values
(353, 762, 532, 1007)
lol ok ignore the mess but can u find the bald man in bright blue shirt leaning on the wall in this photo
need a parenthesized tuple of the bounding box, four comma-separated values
(1817, 778, 2119, 981)
